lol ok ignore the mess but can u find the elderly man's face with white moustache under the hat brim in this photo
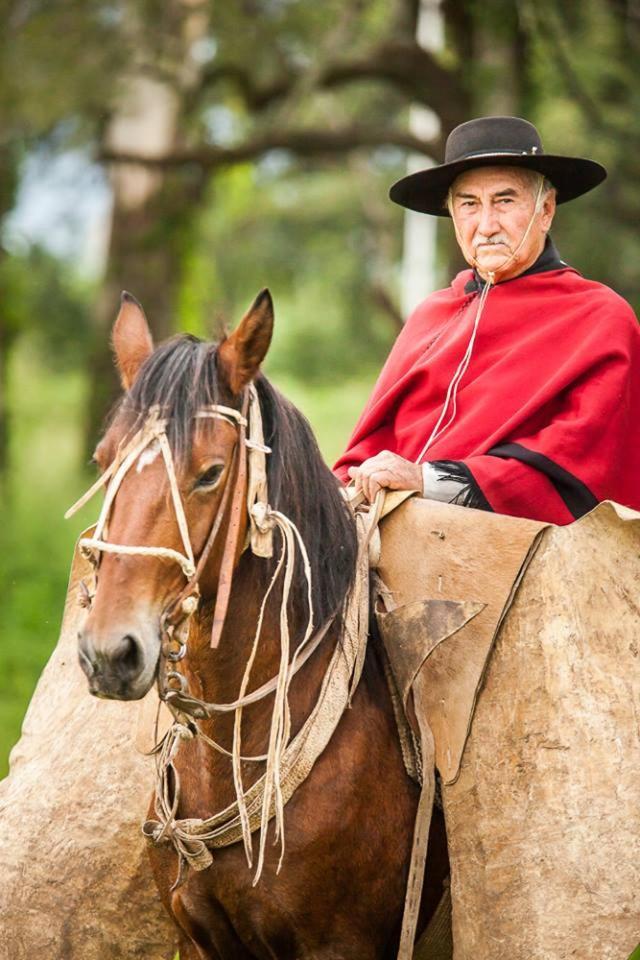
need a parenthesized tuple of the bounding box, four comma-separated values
(451, 167, 555, 280)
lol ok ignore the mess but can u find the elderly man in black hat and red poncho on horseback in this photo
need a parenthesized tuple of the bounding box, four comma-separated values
(335, 117, 640, 524)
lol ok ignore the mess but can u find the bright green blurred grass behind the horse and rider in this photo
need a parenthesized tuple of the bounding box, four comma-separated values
(0, 341, 369, 777)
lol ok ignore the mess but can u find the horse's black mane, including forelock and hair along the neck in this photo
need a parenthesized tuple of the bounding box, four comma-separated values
(118, 335, 357, 627)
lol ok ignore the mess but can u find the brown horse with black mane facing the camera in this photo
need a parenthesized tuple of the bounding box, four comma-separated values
(79, 291, 448, 960)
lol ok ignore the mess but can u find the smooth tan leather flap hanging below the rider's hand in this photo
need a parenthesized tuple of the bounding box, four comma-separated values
(377, 497, 547, 783)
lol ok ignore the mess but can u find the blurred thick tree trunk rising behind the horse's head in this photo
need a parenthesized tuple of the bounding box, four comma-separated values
(87, 0, 207, 445)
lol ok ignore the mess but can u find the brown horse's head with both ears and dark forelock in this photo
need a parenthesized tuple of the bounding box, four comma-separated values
(79, 290, 273, 700)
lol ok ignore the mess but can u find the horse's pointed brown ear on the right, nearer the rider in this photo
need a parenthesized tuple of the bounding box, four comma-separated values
(218, 289, 273, 394)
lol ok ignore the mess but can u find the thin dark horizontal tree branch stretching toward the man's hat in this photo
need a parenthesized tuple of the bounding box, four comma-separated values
(99, 127, 443, 170)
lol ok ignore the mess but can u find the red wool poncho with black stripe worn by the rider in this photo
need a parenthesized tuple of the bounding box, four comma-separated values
(334, 266, 640, 524)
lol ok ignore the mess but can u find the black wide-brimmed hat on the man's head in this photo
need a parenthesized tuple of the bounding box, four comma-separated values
(389, 117, 607, 217)
